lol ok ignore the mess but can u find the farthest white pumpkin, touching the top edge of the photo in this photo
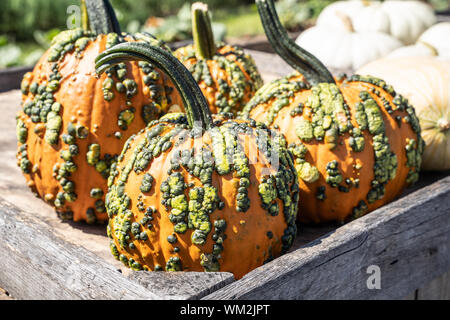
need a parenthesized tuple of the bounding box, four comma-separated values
(317, 0, 436, 45)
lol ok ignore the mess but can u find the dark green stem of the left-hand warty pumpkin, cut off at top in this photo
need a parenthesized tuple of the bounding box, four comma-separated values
(81, 0, 121, 34)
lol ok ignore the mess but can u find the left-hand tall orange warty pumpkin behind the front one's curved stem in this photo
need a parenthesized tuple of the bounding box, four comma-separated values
(17, 0, 181, 223)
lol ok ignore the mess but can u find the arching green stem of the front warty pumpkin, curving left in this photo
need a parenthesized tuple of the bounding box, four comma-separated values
(95, 42, 213, 130)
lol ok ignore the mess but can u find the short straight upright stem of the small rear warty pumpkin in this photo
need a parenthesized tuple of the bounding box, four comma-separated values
(192, 2, 216, 59)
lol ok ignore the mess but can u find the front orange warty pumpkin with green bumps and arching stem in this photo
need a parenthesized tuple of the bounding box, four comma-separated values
(97, 44, 299, 279)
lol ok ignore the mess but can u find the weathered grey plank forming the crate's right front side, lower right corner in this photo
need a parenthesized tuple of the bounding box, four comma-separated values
(205, 176, 450, 299)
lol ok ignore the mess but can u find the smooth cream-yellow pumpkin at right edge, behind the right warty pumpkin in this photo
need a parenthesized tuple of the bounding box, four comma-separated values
(358, 57, 450, 170)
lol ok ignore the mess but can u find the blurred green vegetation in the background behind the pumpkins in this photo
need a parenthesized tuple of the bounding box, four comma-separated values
(0, 0, 450, 68)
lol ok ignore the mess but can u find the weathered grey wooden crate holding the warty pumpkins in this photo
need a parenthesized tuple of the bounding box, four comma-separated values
(0, 51, 450, 299)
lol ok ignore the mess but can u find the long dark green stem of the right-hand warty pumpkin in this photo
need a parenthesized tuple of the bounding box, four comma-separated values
(256, 0, 335, 85)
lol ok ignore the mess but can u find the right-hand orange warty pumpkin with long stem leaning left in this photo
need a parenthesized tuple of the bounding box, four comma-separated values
(241, 0, 424, 223)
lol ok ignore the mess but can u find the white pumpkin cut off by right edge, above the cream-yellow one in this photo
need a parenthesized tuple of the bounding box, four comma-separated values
(387, 22, 450, 61)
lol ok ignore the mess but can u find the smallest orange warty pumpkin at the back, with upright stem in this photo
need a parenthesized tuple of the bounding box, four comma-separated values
(174, 2, 263, 114)
